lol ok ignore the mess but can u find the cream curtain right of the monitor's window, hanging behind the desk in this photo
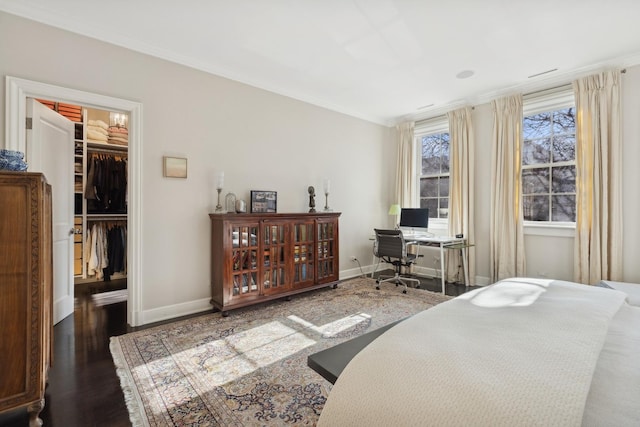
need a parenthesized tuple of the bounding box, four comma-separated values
(446, 107, 476, 286)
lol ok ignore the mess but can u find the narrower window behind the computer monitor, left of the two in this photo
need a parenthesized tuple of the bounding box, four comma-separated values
(415, 118, 449, 220)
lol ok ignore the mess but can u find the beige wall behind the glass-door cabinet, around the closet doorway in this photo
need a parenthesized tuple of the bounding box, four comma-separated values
(0, 12, 395, 323)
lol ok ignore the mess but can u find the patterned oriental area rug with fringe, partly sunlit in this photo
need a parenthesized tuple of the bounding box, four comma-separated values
(110, 278, 450, 426)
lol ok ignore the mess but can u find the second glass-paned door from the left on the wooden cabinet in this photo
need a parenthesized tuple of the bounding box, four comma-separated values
(262, 222, 289, 294)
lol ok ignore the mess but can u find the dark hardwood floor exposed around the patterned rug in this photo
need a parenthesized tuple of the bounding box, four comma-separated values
(0, 271, 470, 427)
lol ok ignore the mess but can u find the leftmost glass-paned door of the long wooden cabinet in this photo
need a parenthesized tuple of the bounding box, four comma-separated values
(231, 224, 259, 297)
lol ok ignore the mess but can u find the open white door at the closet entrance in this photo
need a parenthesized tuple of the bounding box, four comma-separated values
(25, 98, 75, 324)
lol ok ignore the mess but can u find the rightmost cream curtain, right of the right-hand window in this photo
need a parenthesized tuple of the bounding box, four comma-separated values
(573, 71, 622, 284)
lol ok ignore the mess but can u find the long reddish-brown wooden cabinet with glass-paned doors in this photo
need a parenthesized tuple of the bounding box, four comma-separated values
(209, 212, 340, 314)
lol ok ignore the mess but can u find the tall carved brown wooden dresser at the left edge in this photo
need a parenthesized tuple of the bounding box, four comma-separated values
(0, 172, 53, 426)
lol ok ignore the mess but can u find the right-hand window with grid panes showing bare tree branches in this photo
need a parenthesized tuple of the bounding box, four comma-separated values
(522, 90, 576, 222)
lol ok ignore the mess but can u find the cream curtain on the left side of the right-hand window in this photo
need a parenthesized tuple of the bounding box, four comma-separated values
(489, 95, 525, 282)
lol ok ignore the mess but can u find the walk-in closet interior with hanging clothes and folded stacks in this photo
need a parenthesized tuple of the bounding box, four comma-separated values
(38, 99, 129, 334)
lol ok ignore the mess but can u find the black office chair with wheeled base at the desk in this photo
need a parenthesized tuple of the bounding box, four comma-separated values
(373, 228, 422, 294)
